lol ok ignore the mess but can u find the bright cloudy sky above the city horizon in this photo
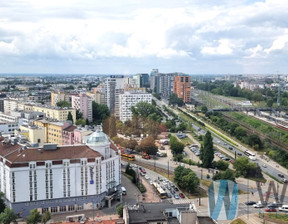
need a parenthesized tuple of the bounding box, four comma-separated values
(0, 0, 288, 74)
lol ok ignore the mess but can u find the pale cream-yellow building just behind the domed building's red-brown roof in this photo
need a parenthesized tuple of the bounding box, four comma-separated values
(19, 125, 46, 146)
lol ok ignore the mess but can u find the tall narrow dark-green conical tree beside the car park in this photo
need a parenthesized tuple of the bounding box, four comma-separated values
(200, 131, 214, 168)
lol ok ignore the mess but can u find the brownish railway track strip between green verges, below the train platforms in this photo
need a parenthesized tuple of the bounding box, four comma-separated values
(222, 113, 288, 152)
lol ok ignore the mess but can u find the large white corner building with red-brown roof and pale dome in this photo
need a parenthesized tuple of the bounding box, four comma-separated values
(0, 131, 121, 217)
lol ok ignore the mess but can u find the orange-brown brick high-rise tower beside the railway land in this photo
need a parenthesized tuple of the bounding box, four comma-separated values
(173, 75, 191, 103)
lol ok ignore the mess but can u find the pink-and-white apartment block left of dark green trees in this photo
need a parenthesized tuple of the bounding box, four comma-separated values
(72, 94, 93, 122)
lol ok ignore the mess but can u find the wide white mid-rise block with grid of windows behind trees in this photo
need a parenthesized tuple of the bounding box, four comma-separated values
(119, 91, 152, 122)
